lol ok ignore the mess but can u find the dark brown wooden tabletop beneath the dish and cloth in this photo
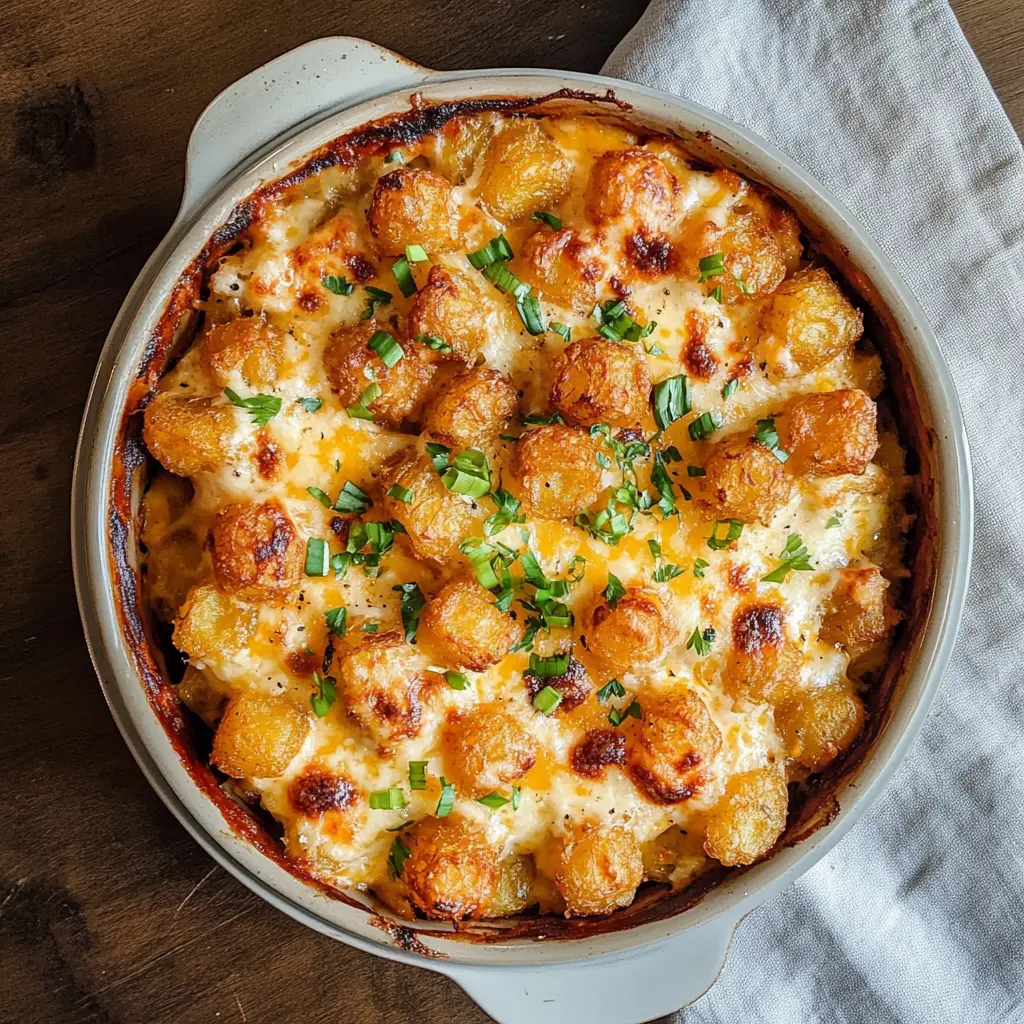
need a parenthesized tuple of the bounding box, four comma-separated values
(0, 0, 1024, 1024)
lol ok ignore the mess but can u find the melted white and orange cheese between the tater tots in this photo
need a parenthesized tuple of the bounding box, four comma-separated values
(140, 112, 903, 909)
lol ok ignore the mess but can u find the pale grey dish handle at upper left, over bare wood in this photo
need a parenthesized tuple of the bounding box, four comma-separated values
(178, 36, 431, 219)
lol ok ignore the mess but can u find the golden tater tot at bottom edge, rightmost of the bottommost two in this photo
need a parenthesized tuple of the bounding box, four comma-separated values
(555, 826, 643, 916)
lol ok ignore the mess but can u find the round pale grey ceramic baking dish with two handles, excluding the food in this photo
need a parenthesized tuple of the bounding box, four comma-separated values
(73, 39, 971, 1022)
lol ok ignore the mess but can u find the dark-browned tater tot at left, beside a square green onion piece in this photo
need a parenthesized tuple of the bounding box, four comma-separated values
(209, 501, 305, 603)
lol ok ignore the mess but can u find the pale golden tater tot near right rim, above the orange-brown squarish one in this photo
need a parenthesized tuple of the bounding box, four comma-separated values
(758, 267, 864, 377)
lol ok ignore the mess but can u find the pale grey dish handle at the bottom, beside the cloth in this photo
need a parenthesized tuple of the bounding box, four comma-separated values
(441, 920, 735, 1024)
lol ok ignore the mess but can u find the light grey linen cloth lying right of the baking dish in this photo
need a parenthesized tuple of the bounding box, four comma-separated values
(604, 0, 1024, 1024)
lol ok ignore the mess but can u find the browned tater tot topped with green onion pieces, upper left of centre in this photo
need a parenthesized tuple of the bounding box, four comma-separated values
(324, 321, 436, 428)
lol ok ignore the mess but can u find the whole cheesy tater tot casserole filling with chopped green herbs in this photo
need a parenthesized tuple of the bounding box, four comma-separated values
(139, 101, 915, 922)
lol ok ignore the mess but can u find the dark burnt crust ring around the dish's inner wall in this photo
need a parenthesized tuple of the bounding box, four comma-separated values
(105, 88, 940, 957)
